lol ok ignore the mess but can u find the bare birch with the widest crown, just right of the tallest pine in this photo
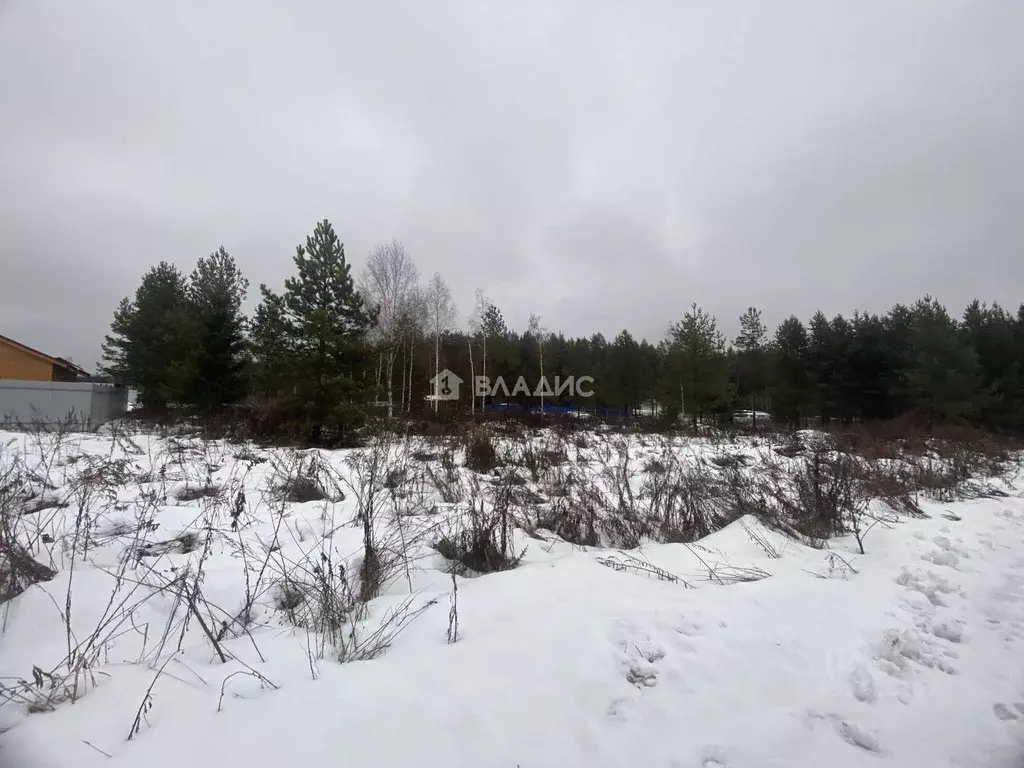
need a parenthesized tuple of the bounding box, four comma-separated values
(360, 240, 420, 418)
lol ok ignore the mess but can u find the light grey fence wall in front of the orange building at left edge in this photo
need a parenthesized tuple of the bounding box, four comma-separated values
(0, 379, 128, 429)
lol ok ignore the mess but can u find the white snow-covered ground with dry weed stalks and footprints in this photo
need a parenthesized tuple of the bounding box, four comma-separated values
(0, 433, 1024, 768)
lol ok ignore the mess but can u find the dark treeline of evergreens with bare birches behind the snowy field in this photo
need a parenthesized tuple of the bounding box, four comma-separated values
(102, 221, 1024, 438)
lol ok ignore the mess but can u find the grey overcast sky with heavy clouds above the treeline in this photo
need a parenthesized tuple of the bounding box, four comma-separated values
(0, 0, 1024, 369)
